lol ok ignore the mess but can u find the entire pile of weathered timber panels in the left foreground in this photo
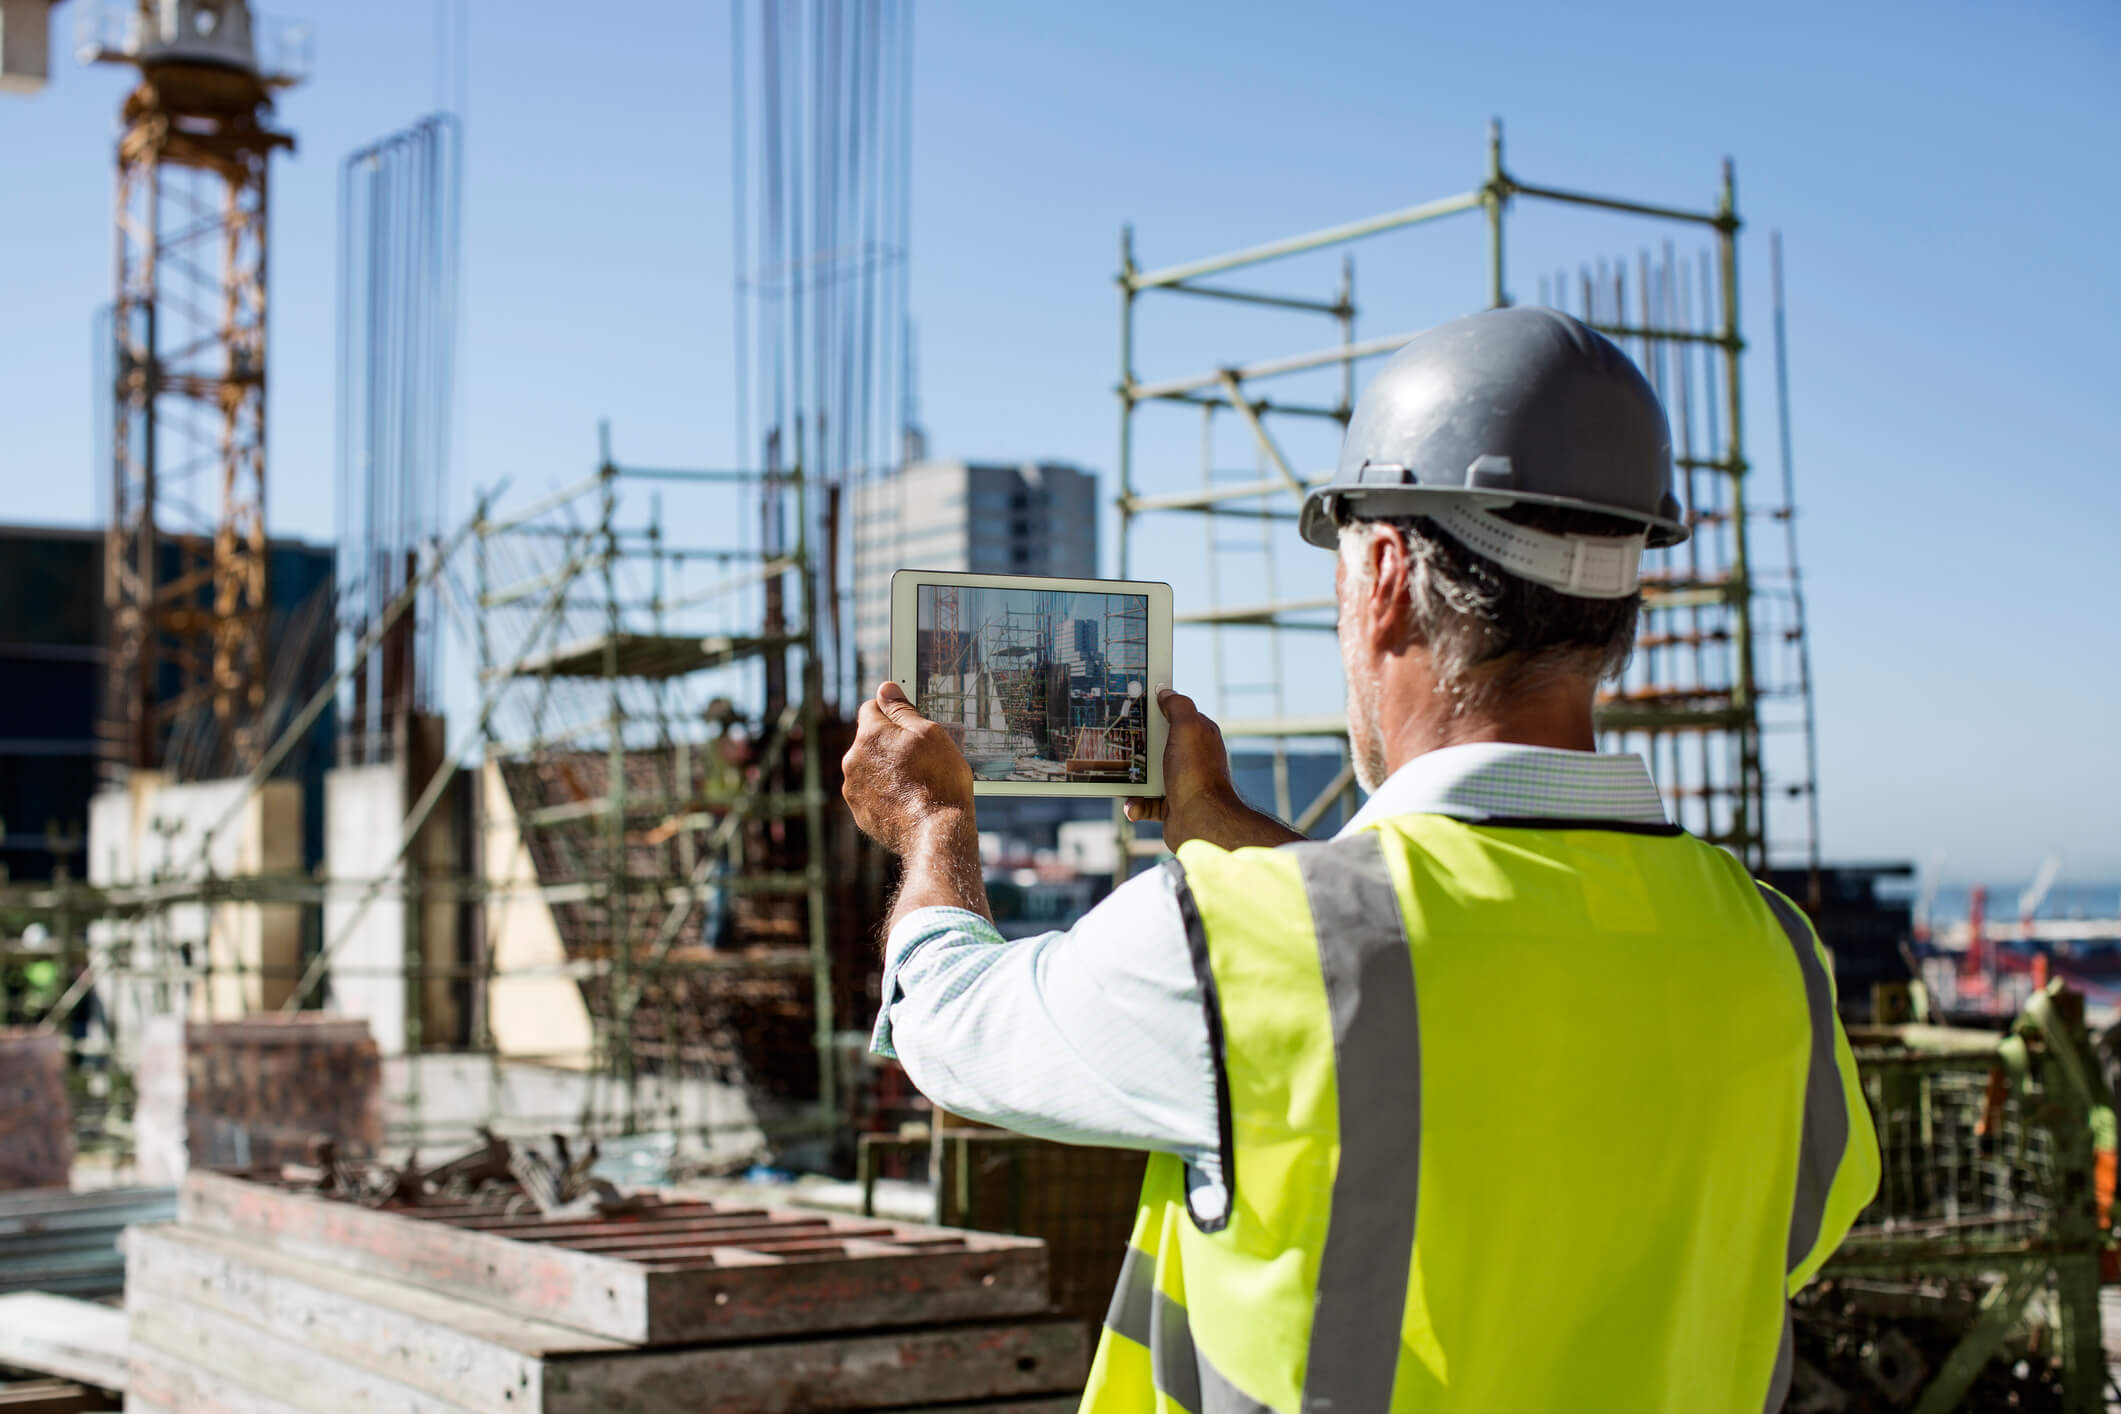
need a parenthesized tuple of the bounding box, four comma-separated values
(125, 1170, 1088, 1414)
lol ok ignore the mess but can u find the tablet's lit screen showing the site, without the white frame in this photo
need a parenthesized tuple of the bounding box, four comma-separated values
(914, 583, 1150, 784)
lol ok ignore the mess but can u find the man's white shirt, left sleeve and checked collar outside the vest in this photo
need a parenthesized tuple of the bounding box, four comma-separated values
(870, 742, 1667, 1210)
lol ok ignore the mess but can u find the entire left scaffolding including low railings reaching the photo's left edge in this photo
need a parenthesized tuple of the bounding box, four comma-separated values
(0, 428, 884, 1164)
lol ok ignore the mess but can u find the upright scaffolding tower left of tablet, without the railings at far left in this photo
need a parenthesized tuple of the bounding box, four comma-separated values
(473, 428, 853, 1130)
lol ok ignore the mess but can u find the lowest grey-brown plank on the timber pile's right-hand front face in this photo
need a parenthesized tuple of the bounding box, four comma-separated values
(537, 1316, 1090, 1414)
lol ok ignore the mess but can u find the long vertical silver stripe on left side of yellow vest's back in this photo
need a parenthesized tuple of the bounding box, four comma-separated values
(1290, 831, 1421, 1414)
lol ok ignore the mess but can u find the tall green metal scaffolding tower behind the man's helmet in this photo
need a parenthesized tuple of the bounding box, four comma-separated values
(1116, 125, 1818, 878)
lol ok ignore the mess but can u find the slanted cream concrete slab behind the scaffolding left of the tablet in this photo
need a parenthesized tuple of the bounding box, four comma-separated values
(479, 761, 596, 1066)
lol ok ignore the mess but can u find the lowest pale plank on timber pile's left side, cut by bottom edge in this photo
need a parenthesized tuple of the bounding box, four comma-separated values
(127, 1293, 477, 1414)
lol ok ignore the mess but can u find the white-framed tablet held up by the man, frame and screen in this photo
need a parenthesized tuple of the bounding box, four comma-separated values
(891, 570, 1171, 795)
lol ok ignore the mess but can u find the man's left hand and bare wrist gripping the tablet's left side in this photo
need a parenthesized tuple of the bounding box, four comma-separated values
(840, 683, 993, 931)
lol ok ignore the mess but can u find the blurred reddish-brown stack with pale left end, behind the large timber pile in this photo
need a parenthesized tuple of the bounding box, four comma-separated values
(138, 1011, 384, 1183)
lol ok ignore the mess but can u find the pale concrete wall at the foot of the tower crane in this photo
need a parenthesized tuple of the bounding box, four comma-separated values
(89, 772, 301, 1039)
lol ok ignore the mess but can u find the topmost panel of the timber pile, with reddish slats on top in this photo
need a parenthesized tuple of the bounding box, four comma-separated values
(178, 1170, 1048, 1346)
